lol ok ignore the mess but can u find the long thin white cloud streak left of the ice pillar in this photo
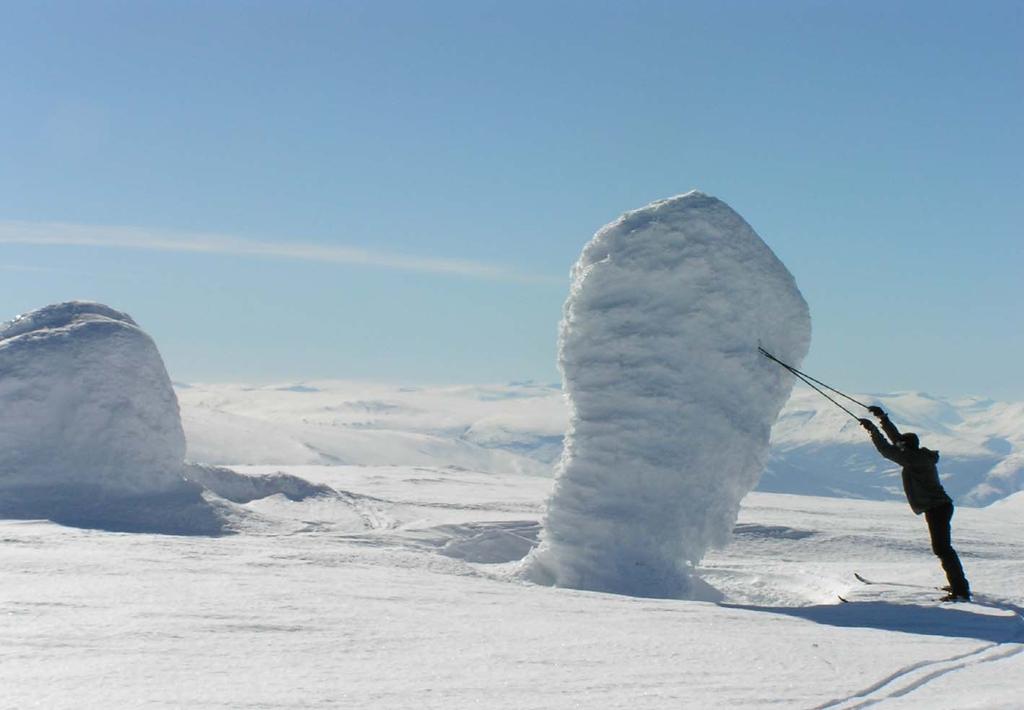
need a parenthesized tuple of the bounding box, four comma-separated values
(0, 220, 552, 282)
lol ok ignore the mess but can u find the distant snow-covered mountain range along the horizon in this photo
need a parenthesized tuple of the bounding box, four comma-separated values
(175, 381, 1024, 505)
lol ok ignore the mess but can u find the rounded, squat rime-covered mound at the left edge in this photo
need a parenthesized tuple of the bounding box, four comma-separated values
(0, 302, 219, 533)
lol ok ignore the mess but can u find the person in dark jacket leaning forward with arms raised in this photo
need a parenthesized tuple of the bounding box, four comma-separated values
(860, 407, 971, 601)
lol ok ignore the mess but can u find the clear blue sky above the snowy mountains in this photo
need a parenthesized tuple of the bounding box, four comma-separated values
(0, 0, 1024, 399)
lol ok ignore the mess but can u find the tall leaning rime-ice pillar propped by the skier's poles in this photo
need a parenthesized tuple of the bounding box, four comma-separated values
(524, 192, 810, 597)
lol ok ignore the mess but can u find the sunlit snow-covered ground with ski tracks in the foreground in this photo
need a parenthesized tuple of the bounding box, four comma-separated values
(0, 465, 1024, 709)
